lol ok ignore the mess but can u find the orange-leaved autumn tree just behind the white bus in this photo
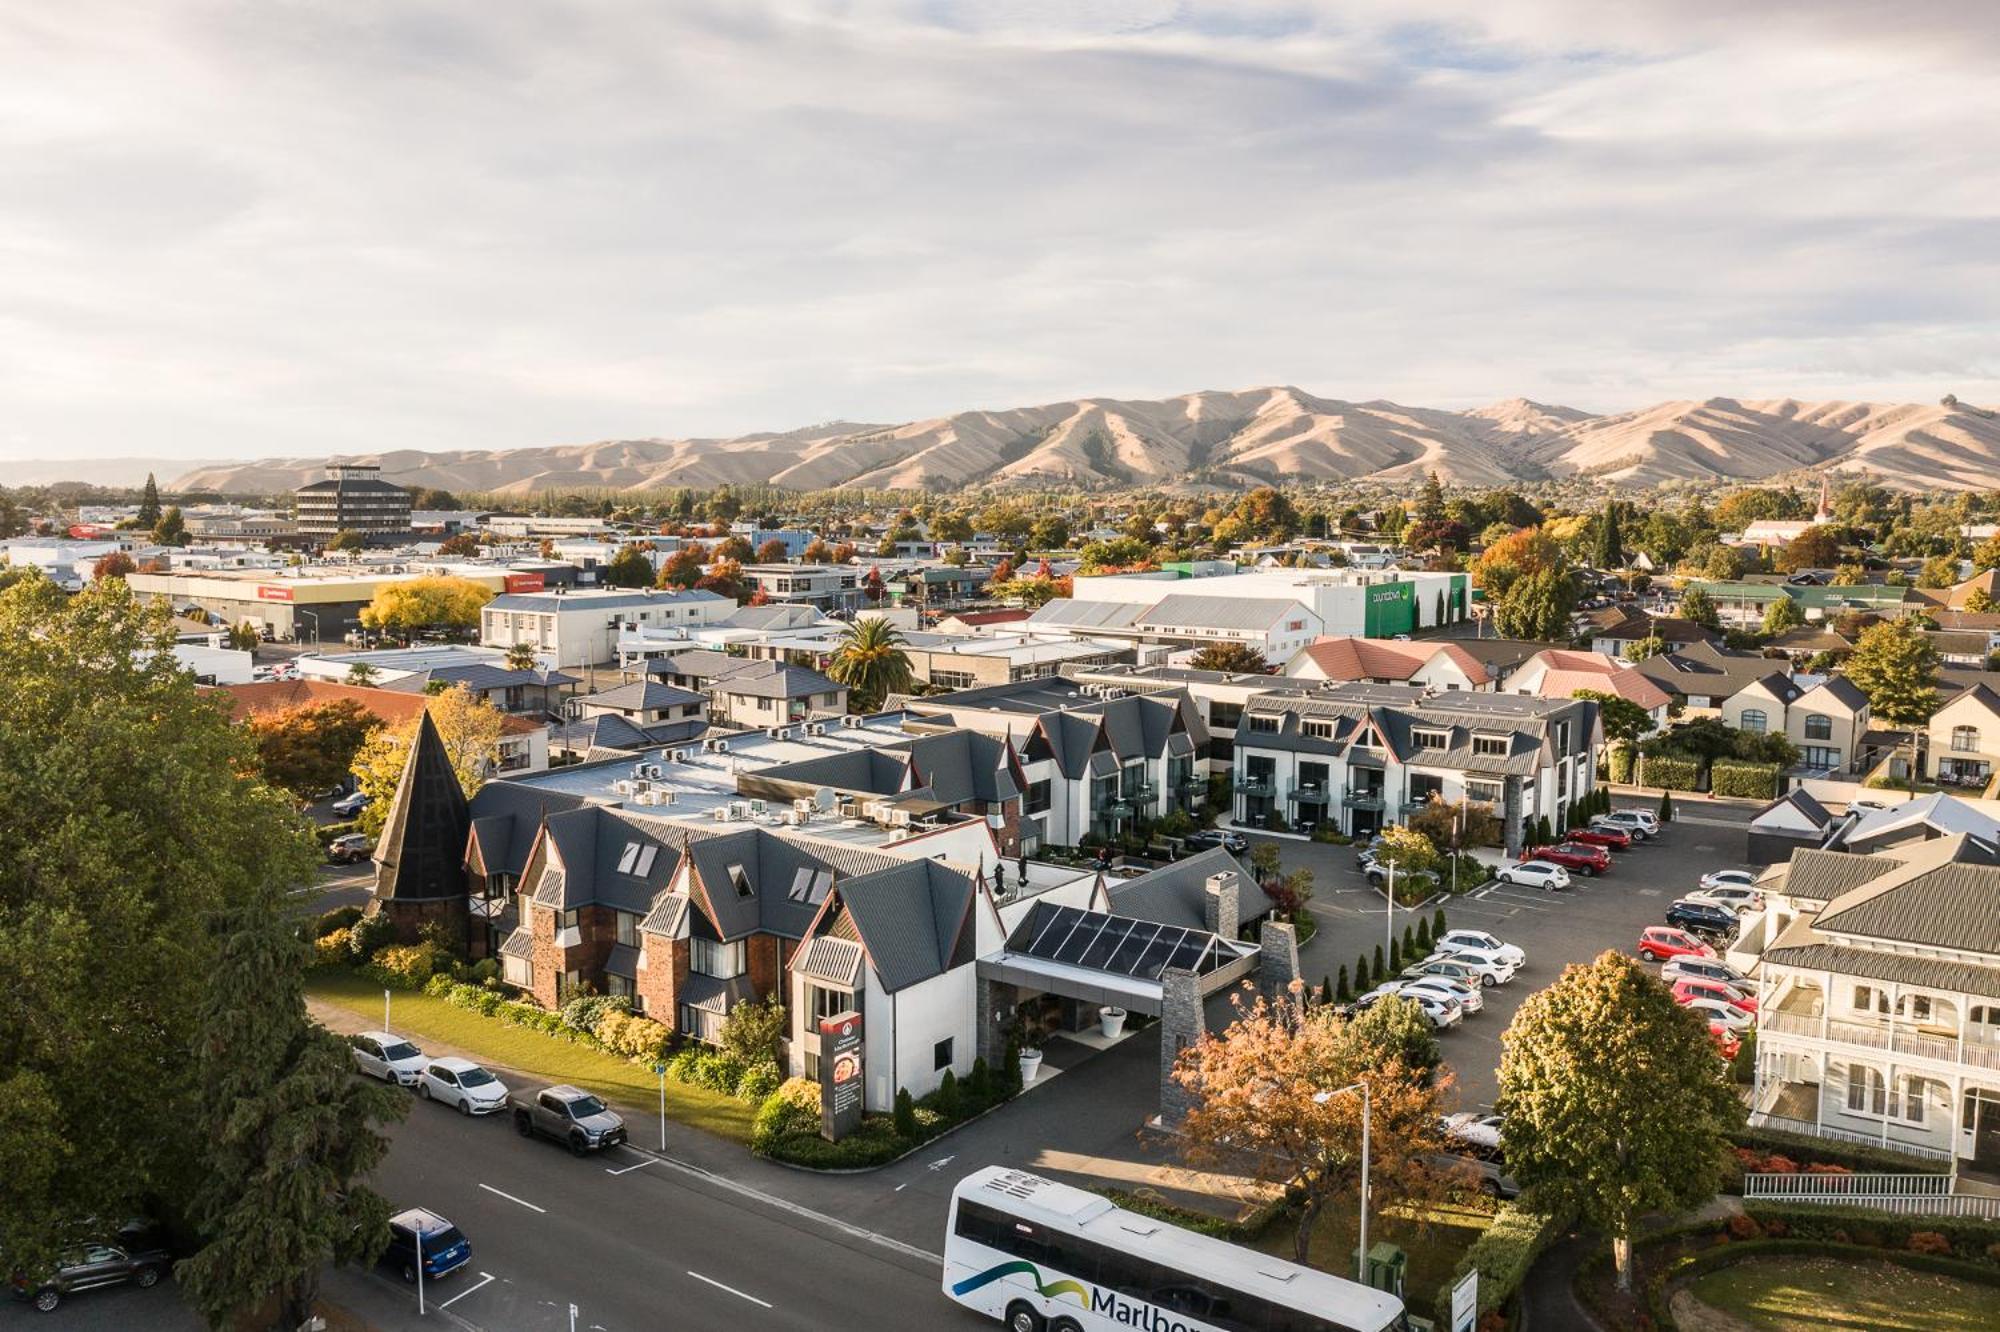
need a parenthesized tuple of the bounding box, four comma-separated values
(1174, 982, 1444, 1264)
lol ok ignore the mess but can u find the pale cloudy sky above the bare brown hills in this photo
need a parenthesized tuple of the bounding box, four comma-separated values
(0, 0, 2000, 462)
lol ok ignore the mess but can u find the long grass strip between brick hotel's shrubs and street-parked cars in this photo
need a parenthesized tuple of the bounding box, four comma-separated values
(306, 972, 756, 1144)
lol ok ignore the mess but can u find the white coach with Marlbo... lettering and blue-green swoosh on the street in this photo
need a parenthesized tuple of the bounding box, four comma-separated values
(944, 1166, 1410, 1332)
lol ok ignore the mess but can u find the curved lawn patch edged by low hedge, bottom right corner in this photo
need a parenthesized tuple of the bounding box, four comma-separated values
(1688, 1256, 2000, 1332)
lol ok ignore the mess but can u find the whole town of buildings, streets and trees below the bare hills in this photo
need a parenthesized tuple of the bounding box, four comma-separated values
(0, 462, 2000, 1332)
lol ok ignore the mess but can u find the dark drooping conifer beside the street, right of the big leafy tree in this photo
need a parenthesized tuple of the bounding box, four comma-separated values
(176, 894, 410, 1328)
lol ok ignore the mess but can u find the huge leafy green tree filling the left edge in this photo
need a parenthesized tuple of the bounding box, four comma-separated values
(0, 576, 318, 1270)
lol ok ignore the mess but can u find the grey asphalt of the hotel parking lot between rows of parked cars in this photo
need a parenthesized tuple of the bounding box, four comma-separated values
(1252, 810, 1752, 1110)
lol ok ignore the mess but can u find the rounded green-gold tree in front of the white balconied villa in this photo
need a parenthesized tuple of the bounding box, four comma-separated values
(1500, 952, 1744, 1288)
